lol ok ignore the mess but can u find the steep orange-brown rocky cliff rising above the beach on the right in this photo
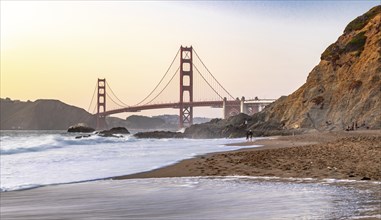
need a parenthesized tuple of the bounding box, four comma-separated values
(251, 6, 381, 130)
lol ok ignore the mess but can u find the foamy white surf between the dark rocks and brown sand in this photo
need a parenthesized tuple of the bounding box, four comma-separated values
(0, 131, 258, 191)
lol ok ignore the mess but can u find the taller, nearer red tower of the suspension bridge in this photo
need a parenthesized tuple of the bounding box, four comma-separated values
(180, 46, 193, 128)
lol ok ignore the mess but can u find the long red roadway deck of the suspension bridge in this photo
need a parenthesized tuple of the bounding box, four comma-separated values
(99, 100, 241, 116)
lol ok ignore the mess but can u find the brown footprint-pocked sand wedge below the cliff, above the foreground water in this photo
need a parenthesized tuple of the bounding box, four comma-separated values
(113, 130, 381, 181)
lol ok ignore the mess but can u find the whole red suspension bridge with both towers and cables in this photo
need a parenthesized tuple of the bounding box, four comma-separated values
(89, 46, 274, 129)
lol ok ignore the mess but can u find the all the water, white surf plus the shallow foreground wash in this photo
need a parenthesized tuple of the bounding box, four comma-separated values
(0, 131, 381, 219)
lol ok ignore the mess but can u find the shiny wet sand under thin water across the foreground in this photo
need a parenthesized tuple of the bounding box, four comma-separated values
(0, 177, 381, 220)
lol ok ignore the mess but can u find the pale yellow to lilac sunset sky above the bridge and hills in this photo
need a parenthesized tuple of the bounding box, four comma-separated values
(0, 0, 381, 117)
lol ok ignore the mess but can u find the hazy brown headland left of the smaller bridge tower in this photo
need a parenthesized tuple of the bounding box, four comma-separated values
(0, 99, 96, 130)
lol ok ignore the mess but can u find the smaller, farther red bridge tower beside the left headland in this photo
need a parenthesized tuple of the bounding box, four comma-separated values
(96, 78, 107, 130)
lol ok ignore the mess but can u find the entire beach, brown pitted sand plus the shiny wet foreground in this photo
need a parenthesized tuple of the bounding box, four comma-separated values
(0, 131, 381, 220)
